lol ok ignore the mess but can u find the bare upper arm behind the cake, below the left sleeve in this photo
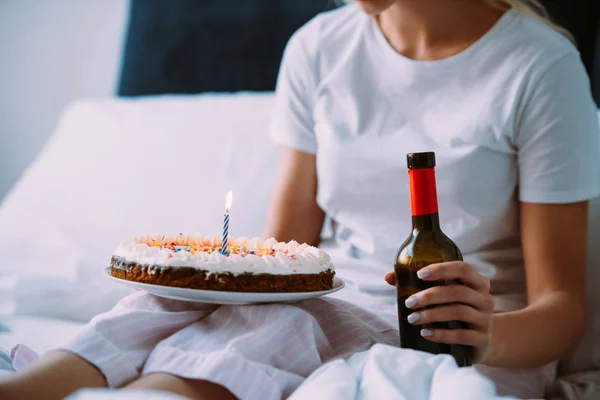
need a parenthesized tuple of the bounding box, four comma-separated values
(265, 147, 325, 246)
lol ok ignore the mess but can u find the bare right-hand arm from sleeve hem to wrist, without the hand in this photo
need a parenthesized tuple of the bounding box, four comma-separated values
(483, 202, 588, 368)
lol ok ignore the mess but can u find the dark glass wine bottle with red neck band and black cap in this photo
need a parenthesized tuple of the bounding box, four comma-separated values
(394, 152, 473, 367)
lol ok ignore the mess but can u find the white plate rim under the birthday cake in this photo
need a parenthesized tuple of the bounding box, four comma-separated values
(106, 268, 345, 305)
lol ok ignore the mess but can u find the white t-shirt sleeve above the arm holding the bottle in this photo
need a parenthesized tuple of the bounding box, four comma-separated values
(516, 53, 600, 203)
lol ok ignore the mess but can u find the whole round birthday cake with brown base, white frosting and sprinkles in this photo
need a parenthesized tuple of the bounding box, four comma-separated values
(110, 234, 335, 292)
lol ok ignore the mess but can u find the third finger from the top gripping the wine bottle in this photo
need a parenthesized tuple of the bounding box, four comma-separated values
(408, 304, 490, 329)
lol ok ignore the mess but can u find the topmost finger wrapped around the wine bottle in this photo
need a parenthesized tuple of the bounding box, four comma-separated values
(417, 261, 490, 293)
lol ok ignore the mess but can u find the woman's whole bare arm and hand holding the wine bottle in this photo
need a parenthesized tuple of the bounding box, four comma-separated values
(386, 201, 588, 368)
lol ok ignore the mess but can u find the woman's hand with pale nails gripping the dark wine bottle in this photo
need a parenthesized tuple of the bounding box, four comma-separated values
(385, 261, 494, 363)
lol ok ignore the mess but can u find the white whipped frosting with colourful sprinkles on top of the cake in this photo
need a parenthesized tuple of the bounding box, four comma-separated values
(115, 234, 333, 275)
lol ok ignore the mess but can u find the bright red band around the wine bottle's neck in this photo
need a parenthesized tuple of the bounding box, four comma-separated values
(408, 168, 438, 216)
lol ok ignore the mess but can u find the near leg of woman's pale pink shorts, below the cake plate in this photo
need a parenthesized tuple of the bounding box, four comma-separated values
(141, 298, 399, 399)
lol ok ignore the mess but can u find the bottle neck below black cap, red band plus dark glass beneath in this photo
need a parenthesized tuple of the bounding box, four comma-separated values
(408, 168, 440, 231)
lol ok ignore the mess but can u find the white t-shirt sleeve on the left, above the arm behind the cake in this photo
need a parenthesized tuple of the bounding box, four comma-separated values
(269, 27, 317, 154)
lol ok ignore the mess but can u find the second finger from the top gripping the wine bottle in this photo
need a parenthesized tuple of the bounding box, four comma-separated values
(405, 285, 494, 313)
